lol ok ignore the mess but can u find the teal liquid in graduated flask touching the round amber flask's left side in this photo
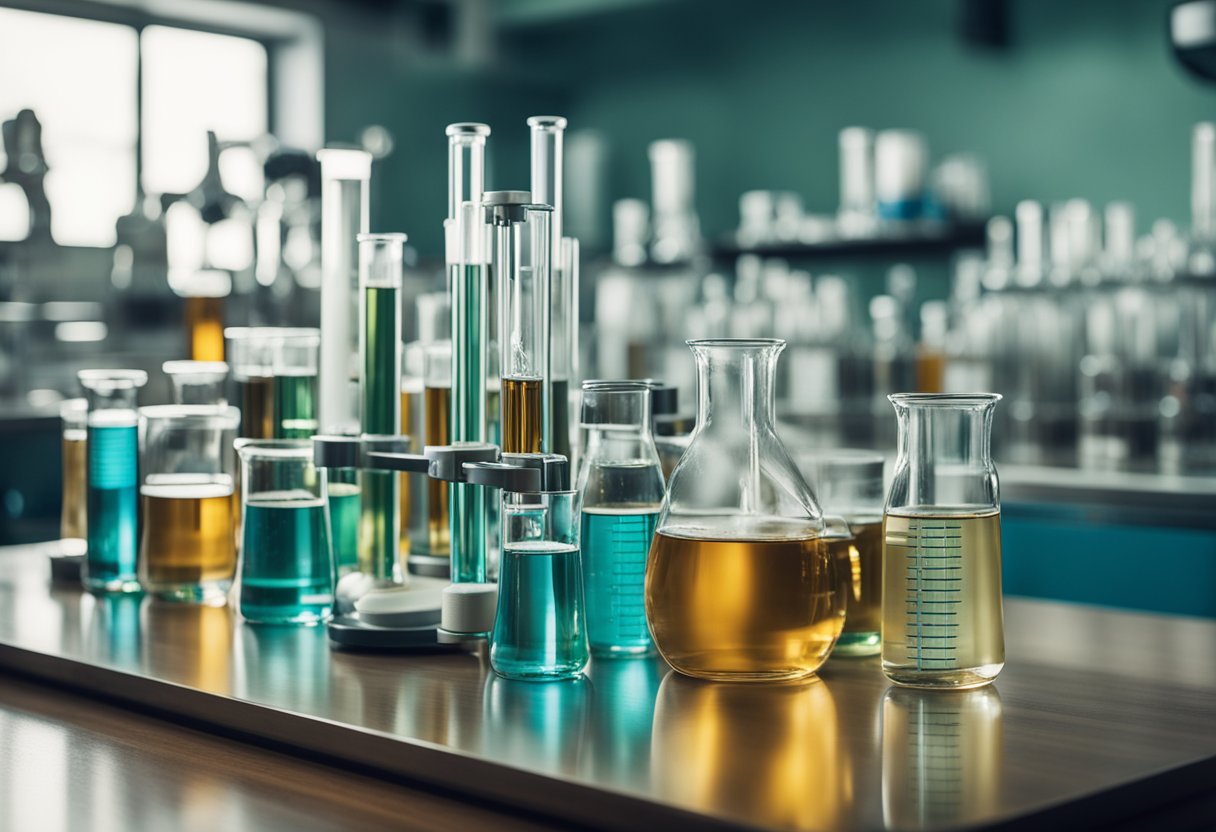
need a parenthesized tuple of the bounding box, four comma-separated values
(582, 507, 659, 656)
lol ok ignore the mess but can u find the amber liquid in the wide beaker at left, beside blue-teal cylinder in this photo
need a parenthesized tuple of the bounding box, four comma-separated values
(140, 478, 236, 600)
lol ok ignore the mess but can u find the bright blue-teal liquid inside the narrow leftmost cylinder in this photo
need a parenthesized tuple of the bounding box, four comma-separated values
(84, 411, 140, 592)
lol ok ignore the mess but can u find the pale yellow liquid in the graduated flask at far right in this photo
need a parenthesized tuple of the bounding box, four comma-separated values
(883, 510, 1004, 688)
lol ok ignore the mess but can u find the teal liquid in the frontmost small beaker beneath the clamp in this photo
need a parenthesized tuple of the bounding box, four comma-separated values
(490, 540, 587, 679)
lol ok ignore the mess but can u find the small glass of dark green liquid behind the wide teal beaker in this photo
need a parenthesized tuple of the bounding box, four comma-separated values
(268, 327, 321, 439)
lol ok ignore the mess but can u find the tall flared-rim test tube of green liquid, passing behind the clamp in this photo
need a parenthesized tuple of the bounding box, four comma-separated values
(444, 124, 490, 583)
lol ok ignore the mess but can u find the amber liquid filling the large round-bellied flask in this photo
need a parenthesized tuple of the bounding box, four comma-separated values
(646, 532, 844, 681)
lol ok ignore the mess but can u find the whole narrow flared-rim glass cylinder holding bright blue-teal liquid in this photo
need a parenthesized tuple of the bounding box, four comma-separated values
(77, 370, 148, 592)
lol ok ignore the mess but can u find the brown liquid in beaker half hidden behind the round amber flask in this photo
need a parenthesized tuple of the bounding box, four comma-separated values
(827, 517, 883, 656)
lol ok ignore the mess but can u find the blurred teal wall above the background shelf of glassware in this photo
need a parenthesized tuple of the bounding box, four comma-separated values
(512, 0, 1216, 250)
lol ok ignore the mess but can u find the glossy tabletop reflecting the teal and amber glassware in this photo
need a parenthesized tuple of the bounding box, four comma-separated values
(0, 546, 1216, 830)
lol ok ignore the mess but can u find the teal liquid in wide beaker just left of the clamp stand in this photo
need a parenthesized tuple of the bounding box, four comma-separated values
(241, 491, 334, 624)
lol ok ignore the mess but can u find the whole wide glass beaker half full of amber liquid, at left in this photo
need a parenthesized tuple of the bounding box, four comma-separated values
(139, 405, 241, 606)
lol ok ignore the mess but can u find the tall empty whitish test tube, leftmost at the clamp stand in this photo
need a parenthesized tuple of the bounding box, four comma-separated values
(316, 150, 367, 433)
